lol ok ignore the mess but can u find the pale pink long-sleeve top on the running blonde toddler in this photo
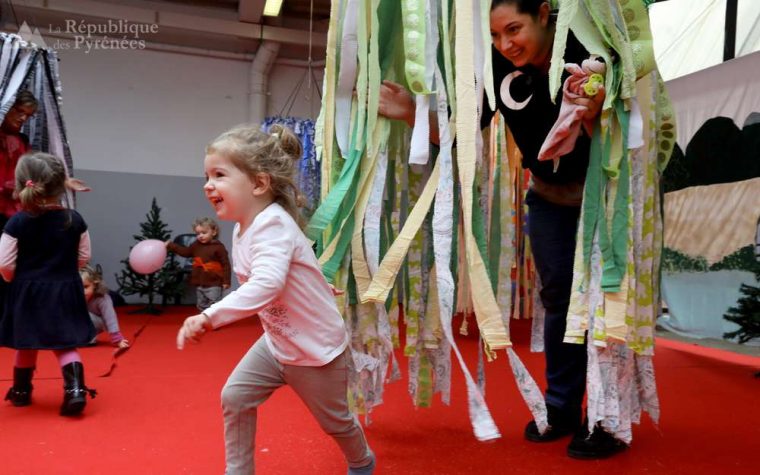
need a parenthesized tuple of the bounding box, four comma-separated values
(204, 203, 348, 366)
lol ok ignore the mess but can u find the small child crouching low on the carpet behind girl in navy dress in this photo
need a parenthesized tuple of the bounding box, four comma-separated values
(79, 266, 129, 349)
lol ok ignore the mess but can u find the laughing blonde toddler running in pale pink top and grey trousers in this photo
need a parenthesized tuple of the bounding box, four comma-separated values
(177, 125, 375, 475)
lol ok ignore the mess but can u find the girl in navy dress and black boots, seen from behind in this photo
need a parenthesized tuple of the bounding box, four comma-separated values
(0, 153, 95, 416)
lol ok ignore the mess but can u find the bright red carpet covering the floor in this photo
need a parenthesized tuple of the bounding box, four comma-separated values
(0, 307, 760, 475)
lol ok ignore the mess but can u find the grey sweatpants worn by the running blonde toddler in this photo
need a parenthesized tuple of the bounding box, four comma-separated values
(222, 336, 372, 475)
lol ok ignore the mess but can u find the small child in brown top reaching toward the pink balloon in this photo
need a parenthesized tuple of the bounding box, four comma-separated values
(166, 218, 230, 312)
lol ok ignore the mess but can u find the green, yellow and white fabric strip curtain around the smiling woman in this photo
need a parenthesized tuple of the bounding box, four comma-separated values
(306, 0, 673, 442)
